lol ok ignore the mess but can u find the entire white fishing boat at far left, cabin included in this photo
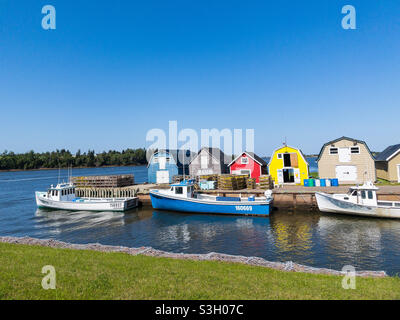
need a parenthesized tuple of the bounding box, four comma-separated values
(35, 183, 139, 211)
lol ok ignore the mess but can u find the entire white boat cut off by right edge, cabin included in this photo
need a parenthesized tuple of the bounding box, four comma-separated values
(315, 182, 400, 218)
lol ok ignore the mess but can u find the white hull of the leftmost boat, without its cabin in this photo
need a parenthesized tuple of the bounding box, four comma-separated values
(36, 192, 139, 211)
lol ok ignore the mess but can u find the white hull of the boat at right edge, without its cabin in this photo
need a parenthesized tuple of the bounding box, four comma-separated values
(315, 192, 400, 219)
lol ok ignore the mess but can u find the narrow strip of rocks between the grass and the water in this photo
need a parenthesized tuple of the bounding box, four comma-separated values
(0, 237, 387, 278)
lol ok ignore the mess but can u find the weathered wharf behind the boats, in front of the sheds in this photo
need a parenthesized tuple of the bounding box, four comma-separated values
(76, 183, 400, 210)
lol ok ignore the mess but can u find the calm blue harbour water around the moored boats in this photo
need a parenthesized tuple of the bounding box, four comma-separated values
(0, 167, 400, 275)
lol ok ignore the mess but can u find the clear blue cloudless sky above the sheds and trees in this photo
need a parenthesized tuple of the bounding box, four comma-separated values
(0, 0, 400, 155)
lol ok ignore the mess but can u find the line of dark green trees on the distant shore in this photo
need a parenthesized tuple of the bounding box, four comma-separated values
(0, 149, 147, 170)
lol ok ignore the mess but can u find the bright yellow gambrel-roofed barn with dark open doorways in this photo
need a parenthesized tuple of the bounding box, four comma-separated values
(268, 145, 308, 185)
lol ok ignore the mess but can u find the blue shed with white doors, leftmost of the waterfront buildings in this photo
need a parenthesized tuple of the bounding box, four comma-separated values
(147, 150, 193, 183)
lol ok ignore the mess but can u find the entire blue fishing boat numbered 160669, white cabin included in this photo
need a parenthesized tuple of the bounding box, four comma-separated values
(150, 181, 273, 216)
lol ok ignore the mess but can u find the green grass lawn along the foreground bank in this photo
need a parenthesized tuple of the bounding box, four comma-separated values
(0, 243, 400, 299)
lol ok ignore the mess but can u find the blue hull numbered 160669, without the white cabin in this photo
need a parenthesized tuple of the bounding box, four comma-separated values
(150, 190, 272, 216)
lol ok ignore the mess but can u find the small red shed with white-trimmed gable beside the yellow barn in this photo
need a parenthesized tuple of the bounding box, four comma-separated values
(228, 152, 268, 182)
